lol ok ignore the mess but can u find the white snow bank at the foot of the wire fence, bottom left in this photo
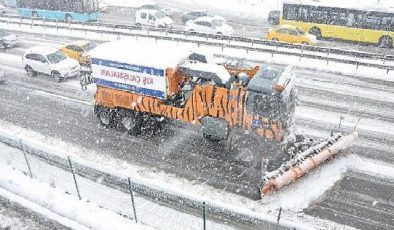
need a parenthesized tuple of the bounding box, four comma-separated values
(0, 162, 150, 230)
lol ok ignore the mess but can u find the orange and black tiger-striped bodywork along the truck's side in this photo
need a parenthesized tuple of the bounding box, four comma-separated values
(95, 84, 284, 141)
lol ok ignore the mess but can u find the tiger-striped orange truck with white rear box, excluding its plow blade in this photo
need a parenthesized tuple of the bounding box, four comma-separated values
(90, 41, 358, 198)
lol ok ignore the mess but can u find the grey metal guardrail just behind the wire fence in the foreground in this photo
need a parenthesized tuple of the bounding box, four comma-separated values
(0, 133, 306, 229)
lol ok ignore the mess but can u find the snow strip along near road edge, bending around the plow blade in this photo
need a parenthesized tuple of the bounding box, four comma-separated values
(0, 117, 394, 229)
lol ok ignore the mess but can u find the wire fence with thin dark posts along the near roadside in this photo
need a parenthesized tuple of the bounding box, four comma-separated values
(0, 135, 304, 230)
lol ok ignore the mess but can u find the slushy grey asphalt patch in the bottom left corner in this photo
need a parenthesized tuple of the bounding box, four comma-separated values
(0, 194, 70, 230)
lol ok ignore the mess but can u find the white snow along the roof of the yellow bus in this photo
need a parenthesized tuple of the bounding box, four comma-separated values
(283, 0, 394, 13)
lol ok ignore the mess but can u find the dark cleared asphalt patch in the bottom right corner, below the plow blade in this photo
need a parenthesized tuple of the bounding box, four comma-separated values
(305, 172, 394, 230)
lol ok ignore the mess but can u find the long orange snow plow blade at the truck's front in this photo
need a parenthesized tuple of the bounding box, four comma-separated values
(260, 132, 358, 197)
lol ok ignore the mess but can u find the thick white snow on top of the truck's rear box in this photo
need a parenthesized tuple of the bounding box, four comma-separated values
(89, 40, 195, 69)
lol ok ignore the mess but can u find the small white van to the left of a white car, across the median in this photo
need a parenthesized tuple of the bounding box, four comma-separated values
(135, 9, 174, 28)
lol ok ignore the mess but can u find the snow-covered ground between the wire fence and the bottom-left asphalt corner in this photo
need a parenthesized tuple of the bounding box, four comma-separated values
(0, 154, 151, 230)
